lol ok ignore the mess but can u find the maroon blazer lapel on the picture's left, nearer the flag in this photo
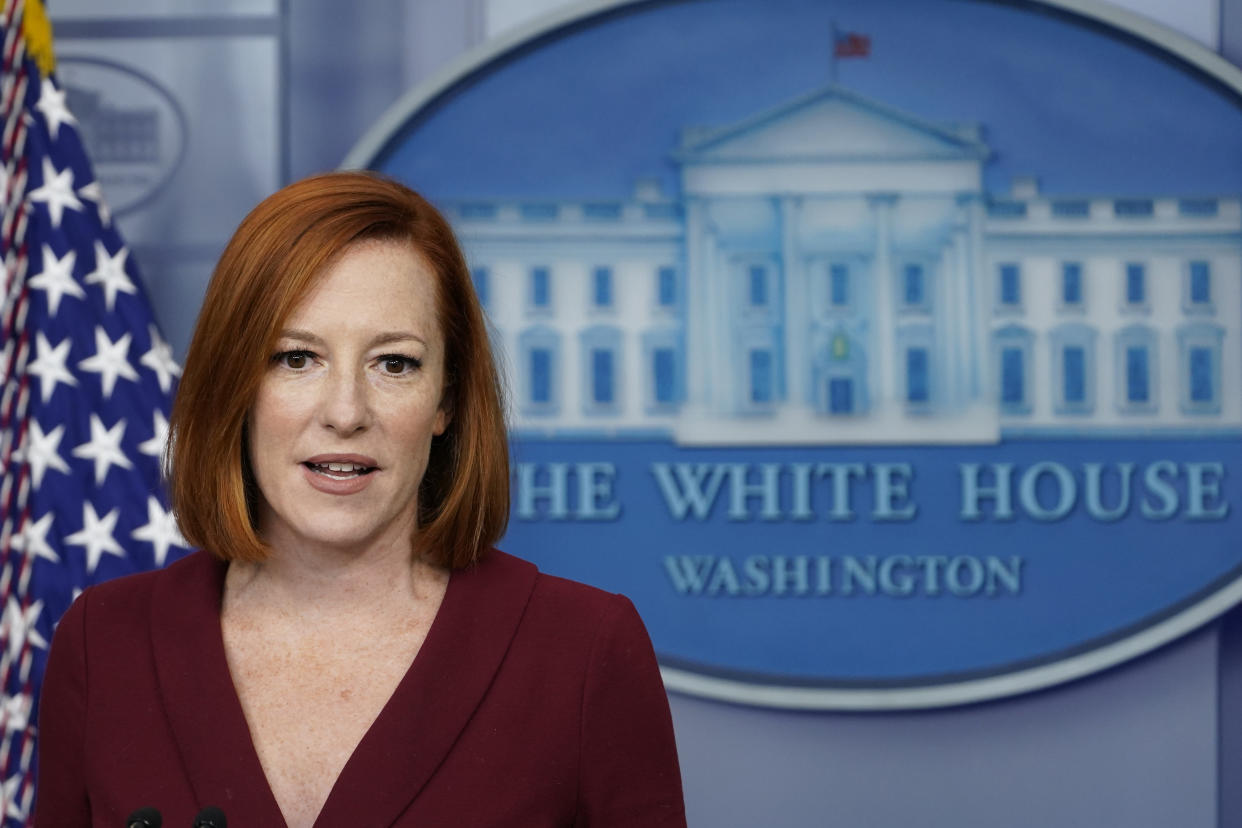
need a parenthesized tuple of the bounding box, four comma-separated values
(150, 551, 284, 826)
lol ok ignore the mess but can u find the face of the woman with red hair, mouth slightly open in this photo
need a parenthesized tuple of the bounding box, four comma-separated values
(248, 235, 447, 554)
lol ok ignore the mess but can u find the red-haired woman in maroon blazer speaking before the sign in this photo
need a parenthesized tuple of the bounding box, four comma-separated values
(36, 173, 684, 828)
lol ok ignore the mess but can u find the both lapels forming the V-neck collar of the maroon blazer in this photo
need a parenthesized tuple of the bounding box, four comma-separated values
(150, 550, 535, 826)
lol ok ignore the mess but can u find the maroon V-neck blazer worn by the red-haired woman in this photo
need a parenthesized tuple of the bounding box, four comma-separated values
(35, 550, 686, 828)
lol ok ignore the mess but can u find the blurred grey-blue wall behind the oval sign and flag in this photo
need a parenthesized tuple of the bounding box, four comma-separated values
(50, 0, 1242, 828)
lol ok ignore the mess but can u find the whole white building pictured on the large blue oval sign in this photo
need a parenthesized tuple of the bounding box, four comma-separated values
(446, 86, 1242, 444)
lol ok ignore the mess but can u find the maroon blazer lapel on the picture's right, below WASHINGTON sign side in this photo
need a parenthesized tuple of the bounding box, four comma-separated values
(312, 550, 537, 826)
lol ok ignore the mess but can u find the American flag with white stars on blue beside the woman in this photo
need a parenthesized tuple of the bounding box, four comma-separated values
(0, 0, 186, 828)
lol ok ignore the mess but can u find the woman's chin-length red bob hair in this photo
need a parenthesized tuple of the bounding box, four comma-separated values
(165, 173, 509, 569)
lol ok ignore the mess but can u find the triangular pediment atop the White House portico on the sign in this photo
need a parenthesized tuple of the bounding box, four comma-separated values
(674, 86, 989, 163)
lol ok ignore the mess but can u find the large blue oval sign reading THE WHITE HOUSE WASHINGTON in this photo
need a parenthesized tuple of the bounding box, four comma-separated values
(347, 0, 1242, 709)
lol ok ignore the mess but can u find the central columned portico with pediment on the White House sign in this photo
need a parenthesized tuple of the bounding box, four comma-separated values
(674, 87, 995, 444)
